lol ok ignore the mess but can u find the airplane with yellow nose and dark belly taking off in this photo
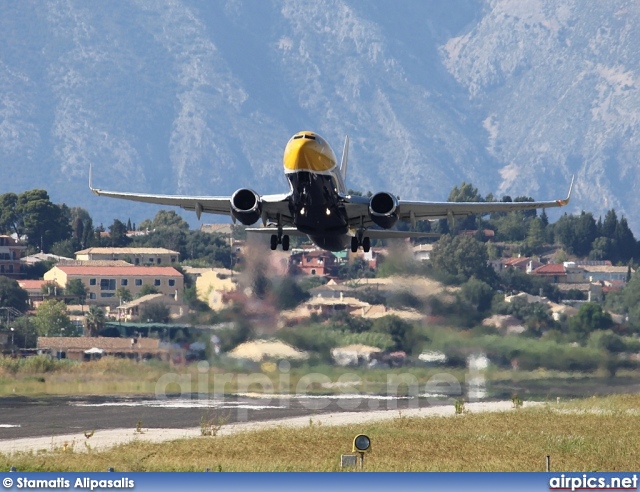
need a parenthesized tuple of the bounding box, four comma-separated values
(89, 131, 573, 253)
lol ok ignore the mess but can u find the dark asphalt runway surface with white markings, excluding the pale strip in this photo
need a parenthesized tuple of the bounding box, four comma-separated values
(0, 395, 453, 440)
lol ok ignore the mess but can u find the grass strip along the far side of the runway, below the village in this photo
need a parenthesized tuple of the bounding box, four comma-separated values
(0, 357, 639, 401)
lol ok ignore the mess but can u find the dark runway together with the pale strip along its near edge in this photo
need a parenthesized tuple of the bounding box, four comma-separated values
(0, 395, 528, 455)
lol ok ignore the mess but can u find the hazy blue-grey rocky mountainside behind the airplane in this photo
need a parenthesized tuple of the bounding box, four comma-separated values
(0, 0, 640, 231)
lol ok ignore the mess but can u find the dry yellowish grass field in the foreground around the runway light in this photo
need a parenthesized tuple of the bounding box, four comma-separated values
(5, 396, 640, 471)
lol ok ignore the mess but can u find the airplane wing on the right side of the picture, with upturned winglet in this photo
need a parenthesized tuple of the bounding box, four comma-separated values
(344, 178, 573, 229)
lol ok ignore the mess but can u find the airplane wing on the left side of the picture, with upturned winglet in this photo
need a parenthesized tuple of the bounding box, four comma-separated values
(89, 169, 293, 224)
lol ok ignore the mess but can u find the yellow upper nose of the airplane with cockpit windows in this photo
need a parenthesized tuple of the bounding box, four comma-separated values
(283, 132, 336, 172)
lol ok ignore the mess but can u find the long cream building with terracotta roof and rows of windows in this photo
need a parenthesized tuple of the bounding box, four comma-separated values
(44, 265, 184, 305)
